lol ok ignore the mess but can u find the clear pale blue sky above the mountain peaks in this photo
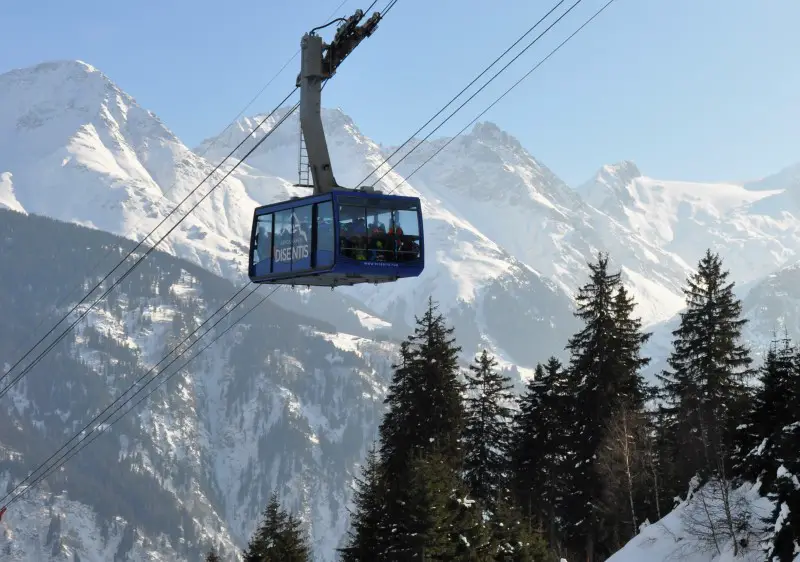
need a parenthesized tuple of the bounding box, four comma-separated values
(0, 0, 800, 184)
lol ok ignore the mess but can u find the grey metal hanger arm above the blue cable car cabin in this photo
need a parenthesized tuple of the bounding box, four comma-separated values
(297, 10, 381, 195)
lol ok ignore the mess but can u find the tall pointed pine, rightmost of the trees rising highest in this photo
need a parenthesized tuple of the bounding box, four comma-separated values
(659, 251, 752, 495)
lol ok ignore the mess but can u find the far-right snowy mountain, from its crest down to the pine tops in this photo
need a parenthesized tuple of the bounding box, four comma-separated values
(578, 162, 800, 376)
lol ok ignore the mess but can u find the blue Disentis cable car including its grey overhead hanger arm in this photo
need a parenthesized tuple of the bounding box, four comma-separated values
(248, 10, 425, 288)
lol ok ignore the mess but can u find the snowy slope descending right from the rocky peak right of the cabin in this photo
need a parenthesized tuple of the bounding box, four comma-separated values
(384, 133, 687, 324)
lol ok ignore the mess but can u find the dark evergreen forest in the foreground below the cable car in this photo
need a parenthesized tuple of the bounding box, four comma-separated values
(207, 251, 800, 562)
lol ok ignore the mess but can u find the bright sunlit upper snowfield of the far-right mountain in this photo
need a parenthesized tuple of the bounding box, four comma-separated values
(578, 162, 800, 283)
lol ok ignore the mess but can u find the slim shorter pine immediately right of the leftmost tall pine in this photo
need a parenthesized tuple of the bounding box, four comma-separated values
(462, 350, 513, 511)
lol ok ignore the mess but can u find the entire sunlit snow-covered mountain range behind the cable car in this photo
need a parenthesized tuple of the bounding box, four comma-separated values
(6, 61, 800, 342)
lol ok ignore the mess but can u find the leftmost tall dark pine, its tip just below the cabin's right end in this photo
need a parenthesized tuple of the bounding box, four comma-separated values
(345, 300, 468, 560)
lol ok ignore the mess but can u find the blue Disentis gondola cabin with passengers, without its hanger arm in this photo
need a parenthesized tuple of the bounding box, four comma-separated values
(248, 190, 425, 287)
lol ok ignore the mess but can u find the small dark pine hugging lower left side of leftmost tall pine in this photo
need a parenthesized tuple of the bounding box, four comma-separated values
(340, 448, 388, 562)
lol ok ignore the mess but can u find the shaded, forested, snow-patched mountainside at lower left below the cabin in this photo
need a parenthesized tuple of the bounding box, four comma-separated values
(0, 209, 397, 562)
